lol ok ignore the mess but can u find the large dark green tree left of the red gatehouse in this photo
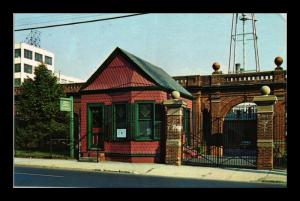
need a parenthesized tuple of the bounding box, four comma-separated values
(15, 64, 67, 148)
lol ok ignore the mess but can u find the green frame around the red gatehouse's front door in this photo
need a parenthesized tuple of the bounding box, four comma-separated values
(87, 103, 104, 150)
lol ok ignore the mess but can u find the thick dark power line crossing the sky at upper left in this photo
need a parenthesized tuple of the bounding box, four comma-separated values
(15, 13, 147, 31)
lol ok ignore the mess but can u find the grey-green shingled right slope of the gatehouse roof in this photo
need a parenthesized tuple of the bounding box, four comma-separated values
(117, 47, 193, 98)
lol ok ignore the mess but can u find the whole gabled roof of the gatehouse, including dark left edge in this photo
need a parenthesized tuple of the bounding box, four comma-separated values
(81, 47, 193, 98)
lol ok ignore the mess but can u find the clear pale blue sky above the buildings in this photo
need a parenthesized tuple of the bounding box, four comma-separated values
(14, 13, 287, 80)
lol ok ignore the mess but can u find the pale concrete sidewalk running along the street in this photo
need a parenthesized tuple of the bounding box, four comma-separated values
(14, 158, 287, 184)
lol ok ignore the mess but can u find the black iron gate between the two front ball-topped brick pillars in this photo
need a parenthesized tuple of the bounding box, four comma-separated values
(183, 103, 257, 168)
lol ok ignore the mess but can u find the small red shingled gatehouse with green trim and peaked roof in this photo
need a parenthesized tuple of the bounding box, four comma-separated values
(80, 47, 192, 163)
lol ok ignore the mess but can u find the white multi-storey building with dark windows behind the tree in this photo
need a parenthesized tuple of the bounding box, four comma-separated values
(14, 43, 55, 86)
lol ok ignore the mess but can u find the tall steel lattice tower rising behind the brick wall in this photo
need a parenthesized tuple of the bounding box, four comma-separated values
(228, 13, 260, 74)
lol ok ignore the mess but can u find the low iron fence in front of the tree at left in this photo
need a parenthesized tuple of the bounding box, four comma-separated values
(14, 114, 78, 158)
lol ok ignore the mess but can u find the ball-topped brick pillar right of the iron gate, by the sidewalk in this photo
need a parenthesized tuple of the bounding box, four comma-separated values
(253, 86, 277, 170)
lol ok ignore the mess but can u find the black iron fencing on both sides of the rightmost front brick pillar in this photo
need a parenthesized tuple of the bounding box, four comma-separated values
(183, 114, 287, 169)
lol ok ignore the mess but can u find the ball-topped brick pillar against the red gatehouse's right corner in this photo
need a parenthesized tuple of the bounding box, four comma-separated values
(164, 92, 187, 165)
